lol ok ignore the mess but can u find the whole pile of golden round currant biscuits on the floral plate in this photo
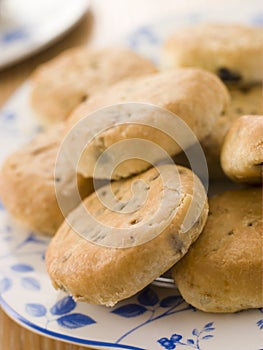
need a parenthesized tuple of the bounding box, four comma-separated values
(0, 23, 263, 312)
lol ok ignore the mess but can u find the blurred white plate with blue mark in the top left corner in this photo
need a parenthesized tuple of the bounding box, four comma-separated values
(0, 0, 89, 69)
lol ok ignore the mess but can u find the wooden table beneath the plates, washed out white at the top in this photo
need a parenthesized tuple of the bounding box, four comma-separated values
(0, 0, 248, 350)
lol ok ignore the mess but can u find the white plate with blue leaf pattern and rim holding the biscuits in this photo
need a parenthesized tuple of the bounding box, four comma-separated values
(0, 5, 263, 350)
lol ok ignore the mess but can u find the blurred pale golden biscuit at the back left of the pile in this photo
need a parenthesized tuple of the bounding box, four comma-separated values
(31, 47, 156, 125)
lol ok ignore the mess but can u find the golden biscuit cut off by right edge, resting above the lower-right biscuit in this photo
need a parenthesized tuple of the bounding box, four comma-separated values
(221, 115, 263, 184)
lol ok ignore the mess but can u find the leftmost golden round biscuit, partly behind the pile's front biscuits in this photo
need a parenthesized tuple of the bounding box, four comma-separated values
(0, 125, 92, 234)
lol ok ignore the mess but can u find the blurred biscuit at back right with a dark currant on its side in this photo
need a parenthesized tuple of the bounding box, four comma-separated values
(162, 23, 263, 85)
